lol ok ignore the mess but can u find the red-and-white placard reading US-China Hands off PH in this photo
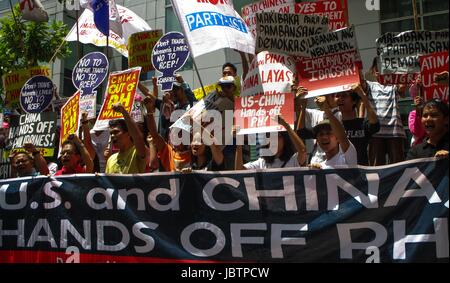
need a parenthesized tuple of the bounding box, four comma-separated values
(234, 93, 295, 135)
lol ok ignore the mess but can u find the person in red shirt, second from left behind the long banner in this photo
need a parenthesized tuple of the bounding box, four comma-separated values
(55, 134, 94, 176)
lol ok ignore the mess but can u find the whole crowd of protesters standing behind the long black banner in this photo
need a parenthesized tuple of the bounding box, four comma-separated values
(0, 63, 449, 178)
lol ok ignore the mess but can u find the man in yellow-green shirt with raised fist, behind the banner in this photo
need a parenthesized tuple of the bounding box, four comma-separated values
(105, 103, 150, 174)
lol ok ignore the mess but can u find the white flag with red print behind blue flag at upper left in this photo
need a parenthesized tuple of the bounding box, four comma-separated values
(66, 5, 151, 57)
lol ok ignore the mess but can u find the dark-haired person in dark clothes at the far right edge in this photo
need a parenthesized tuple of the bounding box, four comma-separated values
(407, 100, 449, 160)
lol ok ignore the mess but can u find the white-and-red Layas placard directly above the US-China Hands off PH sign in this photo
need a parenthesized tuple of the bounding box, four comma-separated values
(241, 51, 296, 96)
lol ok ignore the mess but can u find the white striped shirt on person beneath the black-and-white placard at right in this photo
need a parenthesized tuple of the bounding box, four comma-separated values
(367, 81, 406, 138)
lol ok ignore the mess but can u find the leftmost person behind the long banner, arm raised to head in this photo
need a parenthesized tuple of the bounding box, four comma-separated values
(11, 143, 49, 178)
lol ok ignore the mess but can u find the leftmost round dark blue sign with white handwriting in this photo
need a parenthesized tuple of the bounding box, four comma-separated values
(20, 76, 53, 113)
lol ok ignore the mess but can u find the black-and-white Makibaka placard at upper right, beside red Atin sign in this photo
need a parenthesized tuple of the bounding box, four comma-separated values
(376, 30, 449, 85)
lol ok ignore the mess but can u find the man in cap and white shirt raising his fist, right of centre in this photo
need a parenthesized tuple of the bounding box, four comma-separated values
(311, 96, 357, 169)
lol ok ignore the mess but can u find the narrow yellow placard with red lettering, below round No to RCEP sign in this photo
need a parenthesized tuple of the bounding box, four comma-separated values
(59, 91, 81, 151)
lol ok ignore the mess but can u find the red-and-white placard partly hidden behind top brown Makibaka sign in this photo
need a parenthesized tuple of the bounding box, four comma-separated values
(241, 0, 295, 38)
